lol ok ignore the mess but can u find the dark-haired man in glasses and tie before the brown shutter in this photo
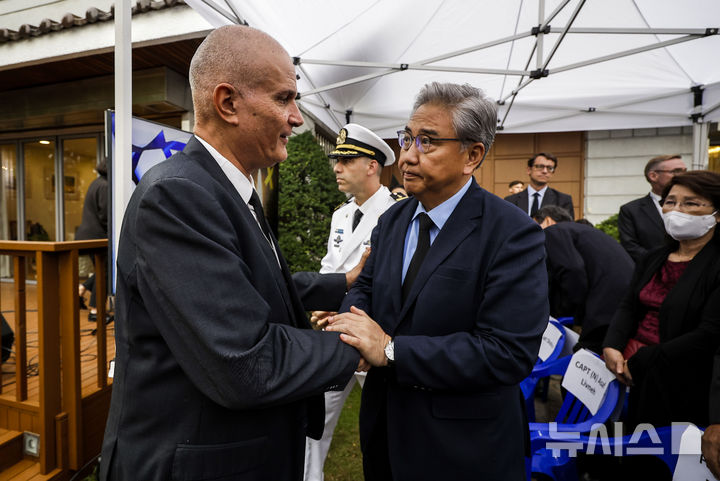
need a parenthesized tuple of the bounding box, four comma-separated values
(505, 152, 575, 218)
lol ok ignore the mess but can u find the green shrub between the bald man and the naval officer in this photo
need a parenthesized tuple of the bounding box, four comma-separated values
(278, 132, 345, 272)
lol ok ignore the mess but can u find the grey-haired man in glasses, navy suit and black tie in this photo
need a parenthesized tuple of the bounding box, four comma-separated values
(327, 82, 548, 481)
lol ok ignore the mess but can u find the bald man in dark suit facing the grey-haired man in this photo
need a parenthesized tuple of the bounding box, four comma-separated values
(100, 26, 360, 481)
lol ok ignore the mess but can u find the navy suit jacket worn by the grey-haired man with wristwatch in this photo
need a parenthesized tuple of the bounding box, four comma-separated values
(341, 180, 548, 481)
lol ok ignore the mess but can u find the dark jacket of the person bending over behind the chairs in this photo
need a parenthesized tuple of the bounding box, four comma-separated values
(545, 222, 635, 353)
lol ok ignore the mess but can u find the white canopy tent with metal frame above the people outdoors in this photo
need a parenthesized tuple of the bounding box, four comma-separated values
(187, 0, 720, 158)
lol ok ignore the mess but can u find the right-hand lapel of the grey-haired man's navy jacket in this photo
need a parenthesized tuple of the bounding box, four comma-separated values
(398, 179, 483, 319)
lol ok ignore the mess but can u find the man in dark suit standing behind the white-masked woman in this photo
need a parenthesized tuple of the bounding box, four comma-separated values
(618, 154, 687, 262)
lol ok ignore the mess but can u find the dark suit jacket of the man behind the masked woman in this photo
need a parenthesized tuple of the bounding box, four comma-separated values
(618, 194, 667, 262)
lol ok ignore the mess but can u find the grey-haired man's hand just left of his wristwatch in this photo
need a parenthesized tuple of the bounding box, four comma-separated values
(325, 306, 390, 367)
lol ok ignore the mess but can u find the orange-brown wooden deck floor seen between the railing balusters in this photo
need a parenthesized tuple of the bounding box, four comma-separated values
(0, 282, 115, 404)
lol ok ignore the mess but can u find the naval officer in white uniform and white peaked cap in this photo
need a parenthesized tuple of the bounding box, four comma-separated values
(305, 124, 404, 481)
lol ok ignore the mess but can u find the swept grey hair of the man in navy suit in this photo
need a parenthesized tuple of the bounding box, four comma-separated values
(412, 82, 497, 159)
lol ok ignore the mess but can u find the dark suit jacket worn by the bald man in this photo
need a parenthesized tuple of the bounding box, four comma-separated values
(100, 138, 359, 481)
